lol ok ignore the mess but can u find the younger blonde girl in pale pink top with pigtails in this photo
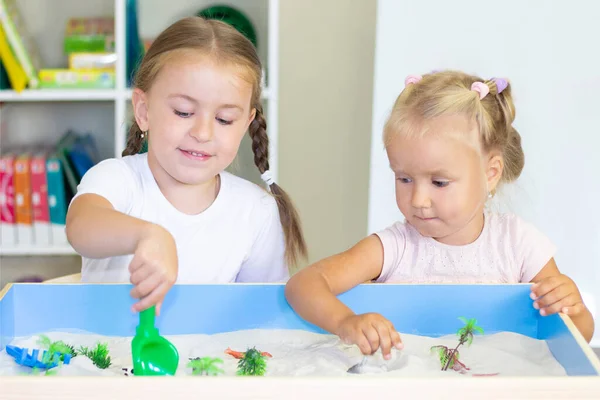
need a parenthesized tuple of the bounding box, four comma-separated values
(286, 71, 594, 359)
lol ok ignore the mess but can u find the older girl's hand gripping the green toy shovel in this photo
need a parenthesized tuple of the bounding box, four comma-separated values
(129, 224, 178, 315)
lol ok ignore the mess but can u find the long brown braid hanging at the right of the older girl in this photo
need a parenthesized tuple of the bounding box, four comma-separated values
(248, 104, 307, 265)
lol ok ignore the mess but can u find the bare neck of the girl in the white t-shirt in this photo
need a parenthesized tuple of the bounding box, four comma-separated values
(148, 157, 221, 215)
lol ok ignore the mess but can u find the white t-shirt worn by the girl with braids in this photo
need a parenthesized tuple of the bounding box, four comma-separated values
(75, 154, 289, 284)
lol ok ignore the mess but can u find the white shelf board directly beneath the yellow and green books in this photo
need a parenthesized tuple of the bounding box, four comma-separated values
(0, 89, 117, 102)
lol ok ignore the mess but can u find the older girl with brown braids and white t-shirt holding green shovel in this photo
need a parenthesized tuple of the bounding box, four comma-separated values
(67, 17, 306, 313)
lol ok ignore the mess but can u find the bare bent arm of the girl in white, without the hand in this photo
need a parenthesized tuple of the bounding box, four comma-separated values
(66, 193, 159, 258)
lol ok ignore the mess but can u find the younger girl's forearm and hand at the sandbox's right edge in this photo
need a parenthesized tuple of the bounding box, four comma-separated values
(531, 258, 594, 343)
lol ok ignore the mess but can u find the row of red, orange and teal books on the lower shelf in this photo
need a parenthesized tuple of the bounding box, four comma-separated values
(0, 131, 99, 250)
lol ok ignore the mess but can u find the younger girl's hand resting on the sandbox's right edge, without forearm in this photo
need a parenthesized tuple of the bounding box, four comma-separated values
(531, 274, 586, 317)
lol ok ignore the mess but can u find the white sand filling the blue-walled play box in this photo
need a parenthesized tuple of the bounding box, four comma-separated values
(0, 329, 566, 377)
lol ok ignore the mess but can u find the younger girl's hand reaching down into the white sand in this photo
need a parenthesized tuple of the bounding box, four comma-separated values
(335, 313, 403, 360)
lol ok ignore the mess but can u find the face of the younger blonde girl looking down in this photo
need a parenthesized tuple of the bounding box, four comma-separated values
(386, 112, 502, 245)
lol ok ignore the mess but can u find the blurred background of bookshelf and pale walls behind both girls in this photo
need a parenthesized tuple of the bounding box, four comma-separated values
(0, 0, 600, 346)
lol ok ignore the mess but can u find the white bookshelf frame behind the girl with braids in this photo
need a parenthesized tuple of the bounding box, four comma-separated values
(0, 0, 279, 256)
